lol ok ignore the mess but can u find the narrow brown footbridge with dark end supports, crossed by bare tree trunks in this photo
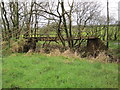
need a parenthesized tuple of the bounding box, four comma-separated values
(24, 35, 105, 52)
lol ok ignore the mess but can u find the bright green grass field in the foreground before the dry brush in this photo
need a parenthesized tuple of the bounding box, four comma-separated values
(2, 54, 118, 88)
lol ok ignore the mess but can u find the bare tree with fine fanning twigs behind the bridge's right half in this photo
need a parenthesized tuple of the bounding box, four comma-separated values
(74, 1, 100, 46)
